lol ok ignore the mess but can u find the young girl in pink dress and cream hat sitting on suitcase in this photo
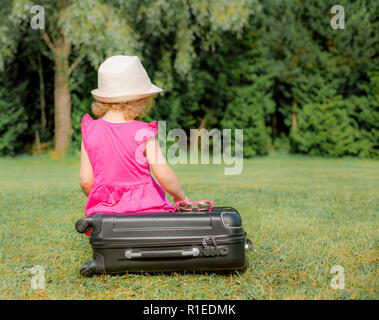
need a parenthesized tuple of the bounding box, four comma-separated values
(80, 56, 188, 216)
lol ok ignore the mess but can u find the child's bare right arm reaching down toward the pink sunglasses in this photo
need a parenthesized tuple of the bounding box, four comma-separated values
(146, 137, 189, 201)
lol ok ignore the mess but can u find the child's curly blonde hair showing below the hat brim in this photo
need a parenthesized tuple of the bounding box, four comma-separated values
(91, 96, 154, 121)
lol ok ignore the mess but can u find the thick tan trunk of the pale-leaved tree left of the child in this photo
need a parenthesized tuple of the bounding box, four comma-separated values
(54, 39, 72, 157)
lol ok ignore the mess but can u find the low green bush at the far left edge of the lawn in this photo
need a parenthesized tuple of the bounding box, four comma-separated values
(0, 74, 28, 156)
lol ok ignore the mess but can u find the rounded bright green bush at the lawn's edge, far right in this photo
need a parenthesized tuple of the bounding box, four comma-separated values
(291, 91, 379, 158)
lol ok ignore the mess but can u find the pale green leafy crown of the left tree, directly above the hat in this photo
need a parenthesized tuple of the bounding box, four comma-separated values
(60, 0, 139, 67)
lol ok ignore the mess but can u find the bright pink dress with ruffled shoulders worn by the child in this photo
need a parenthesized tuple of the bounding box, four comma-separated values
(81, 114, 175, 216)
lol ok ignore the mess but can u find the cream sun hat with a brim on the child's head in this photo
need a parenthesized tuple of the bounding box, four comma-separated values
(91, 56, 163, 103)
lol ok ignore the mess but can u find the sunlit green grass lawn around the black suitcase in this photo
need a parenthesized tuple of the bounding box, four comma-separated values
(0, 156, 379, 299)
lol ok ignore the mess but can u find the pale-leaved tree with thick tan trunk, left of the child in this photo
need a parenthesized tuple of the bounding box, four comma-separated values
(5, 0, 137, 157)
